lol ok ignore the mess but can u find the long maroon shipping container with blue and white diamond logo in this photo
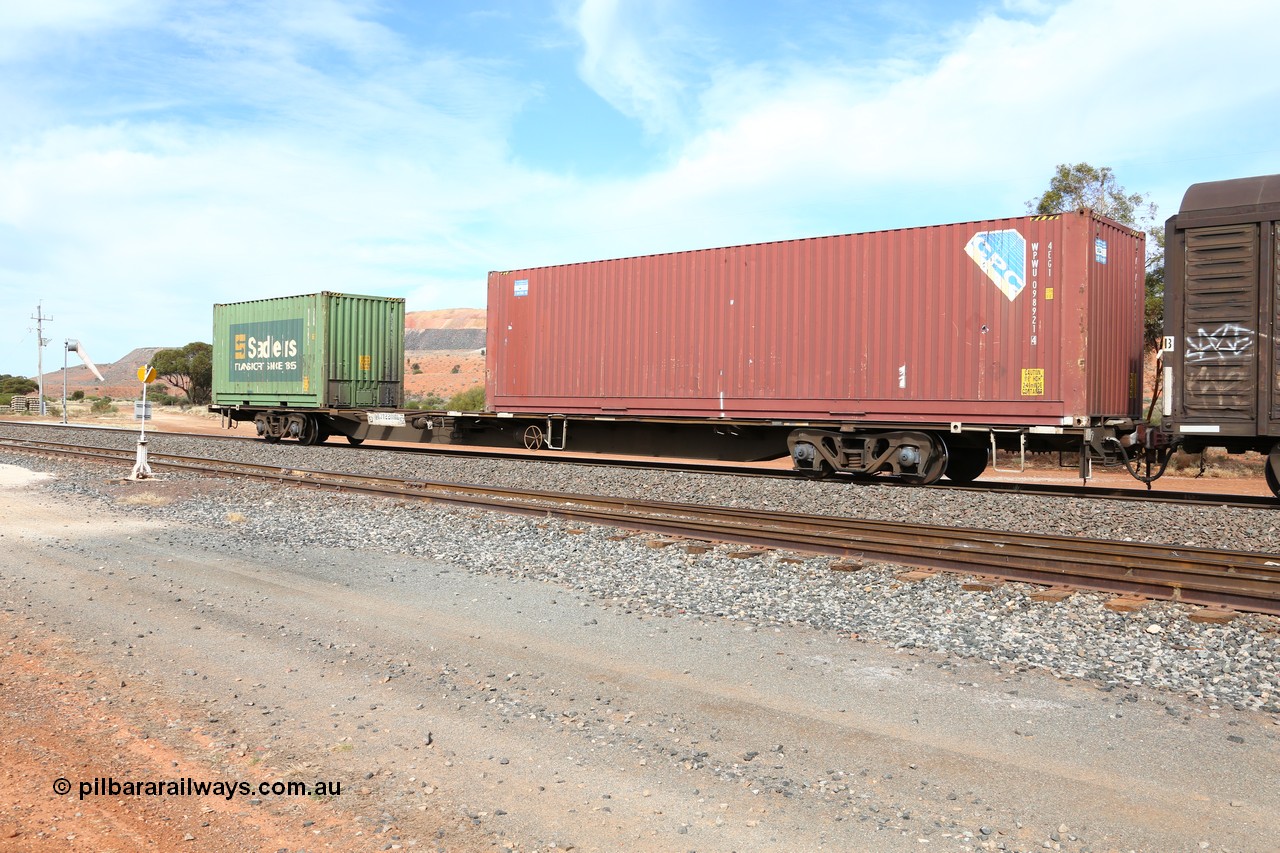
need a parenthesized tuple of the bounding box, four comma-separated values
(486, 211, 1144, 427)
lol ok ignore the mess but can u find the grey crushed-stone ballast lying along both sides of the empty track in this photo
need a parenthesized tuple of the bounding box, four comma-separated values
(0, 425, 1280, 713)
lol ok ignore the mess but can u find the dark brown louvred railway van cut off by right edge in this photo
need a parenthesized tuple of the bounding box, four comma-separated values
(1161, 175, 1280, 496)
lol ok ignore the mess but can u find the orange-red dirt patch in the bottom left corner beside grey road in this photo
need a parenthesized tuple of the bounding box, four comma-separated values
(0, 625, 369, 853)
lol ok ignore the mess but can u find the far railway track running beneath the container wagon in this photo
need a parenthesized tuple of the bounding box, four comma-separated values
(0, 421, 1280, 508)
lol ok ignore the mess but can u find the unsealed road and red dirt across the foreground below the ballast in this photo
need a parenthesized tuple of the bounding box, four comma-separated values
(0, 461, 1280, 850)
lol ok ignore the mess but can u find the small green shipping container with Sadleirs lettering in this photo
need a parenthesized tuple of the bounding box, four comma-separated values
(214, 292, 404, 409)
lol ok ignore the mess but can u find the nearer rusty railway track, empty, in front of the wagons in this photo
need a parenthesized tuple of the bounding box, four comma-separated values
(0, 439, 1280, 615)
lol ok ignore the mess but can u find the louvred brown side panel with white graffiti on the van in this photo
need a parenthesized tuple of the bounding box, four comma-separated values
(1183, 223, 1260, 425)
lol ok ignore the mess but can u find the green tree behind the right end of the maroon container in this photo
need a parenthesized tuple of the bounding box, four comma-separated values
(1027, 163, 1165, 350)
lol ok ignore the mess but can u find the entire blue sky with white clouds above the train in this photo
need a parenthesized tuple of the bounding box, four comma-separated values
(0, 0, 1280, 375)
